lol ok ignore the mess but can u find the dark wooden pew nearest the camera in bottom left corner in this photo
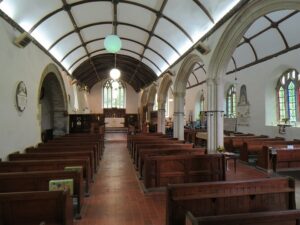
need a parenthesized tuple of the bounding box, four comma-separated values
(0, 191, 73, 225)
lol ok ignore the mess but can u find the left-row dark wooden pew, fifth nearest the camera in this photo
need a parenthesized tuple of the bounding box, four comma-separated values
(25, 145, 99, 172)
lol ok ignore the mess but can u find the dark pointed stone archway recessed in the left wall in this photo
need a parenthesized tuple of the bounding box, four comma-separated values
(38, 64, 68, 139)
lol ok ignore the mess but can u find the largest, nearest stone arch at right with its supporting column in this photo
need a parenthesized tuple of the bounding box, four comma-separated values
(207, 0, 300, 151)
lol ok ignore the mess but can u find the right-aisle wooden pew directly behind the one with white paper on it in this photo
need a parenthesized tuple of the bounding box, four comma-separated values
(240, 137, 285, 162)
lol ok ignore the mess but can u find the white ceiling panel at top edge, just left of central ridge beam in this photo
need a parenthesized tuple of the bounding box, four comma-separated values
(71, 1, 113, 27)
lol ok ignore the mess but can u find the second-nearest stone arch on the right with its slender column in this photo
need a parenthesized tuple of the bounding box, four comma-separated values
(173, 54, 202, 140)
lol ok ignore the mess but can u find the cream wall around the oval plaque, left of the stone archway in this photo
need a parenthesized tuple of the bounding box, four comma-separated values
(0, 18, 73, 160)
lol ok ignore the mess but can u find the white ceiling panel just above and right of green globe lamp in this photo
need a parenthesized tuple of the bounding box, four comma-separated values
(118, 25, 149, 44)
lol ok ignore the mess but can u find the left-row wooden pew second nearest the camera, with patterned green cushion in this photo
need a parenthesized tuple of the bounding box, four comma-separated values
(0, 170, 84, 219)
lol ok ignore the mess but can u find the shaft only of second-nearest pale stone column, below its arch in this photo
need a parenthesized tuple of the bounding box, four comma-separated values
(173, 92, 185, 140)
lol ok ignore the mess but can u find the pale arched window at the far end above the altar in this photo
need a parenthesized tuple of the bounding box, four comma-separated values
(103, 80, 126, 108)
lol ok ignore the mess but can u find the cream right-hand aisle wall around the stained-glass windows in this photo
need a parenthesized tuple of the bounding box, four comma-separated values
(224, 49, 300, 139)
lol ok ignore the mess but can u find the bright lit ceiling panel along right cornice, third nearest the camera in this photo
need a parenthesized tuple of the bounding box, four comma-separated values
(154, 18, 193, 54)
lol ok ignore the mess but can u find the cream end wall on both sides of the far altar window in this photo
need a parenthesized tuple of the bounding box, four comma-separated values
(88, 82, 139, 113)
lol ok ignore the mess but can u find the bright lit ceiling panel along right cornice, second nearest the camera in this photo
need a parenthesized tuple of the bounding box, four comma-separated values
(163, 0, 213, 42)
